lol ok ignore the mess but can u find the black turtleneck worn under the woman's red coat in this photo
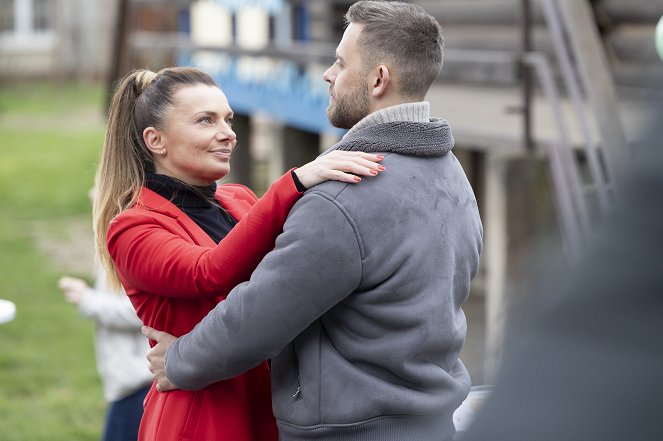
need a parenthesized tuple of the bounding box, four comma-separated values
(145, 173, 237, 243)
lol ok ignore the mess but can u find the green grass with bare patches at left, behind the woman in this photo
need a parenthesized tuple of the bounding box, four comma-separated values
(0, 83, 105, 441)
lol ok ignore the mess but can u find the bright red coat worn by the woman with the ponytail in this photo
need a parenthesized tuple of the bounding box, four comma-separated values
(107, 173, 300, 441)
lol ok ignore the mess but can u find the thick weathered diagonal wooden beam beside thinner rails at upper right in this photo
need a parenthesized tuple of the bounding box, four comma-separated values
(558, 0, 632, 190)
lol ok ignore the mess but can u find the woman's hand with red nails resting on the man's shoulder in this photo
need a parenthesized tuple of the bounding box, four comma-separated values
(295, 150, 384, 188)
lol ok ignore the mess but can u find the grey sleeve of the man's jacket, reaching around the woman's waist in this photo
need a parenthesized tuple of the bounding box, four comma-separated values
(166, 191, 362, 390)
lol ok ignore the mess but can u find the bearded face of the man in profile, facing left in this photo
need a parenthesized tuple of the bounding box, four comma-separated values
(322, 23, 370, 129)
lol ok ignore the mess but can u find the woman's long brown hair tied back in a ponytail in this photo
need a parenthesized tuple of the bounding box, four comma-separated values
(92, 67, 218, 288)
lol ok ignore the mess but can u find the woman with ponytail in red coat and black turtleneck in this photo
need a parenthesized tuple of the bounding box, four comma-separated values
(94, 68, 383, 441)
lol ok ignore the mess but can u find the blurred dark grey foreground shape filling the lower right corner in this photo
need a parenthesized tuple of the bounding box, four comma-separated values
(460, 103, 663, 441)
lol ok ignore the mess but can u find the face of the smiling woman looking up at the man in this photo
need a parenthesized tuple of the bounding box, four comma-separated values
(149, 84, 237, 186)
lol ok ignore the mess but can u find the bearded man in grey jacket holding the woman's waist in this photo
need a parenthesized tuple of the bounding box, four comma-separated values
(146, 1, 482, 441)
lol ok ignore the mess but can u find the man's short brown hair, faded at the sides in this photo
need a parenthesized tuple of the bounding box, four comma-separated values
(345, 0, 444, 97)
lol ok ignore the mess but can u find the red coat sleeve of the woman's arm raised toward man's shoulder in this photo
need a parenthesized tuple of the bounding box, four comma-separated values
(107, 172, 301, 298)
